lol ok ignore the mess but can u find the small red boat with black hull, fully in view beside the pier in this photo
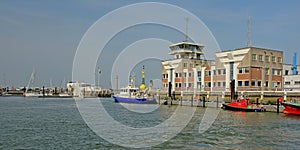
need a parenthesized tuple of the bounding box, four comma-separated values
(222, 98, 266, 112)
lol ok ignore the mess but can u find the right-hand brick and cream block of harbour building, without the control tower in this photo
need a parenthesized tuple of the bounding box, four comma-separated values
(212, 47, 283, 91)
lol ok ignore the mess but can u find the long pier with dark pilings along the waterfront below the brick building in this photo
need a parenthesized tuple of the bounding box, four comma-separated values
(151, 91, 300, 112)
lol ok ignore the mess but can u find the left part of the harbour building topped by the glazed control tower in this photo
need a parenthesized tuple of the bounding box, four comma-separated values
(162, 42, 208, 91)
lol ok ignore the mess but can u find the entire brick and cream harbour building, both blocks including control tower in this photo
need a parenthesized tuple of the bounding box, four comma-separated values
(162, 45, 283, 91)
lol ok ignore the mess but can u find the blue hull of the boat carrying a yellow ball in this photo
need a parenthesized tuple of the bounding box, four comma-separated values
(113, 96, 156, 104)
